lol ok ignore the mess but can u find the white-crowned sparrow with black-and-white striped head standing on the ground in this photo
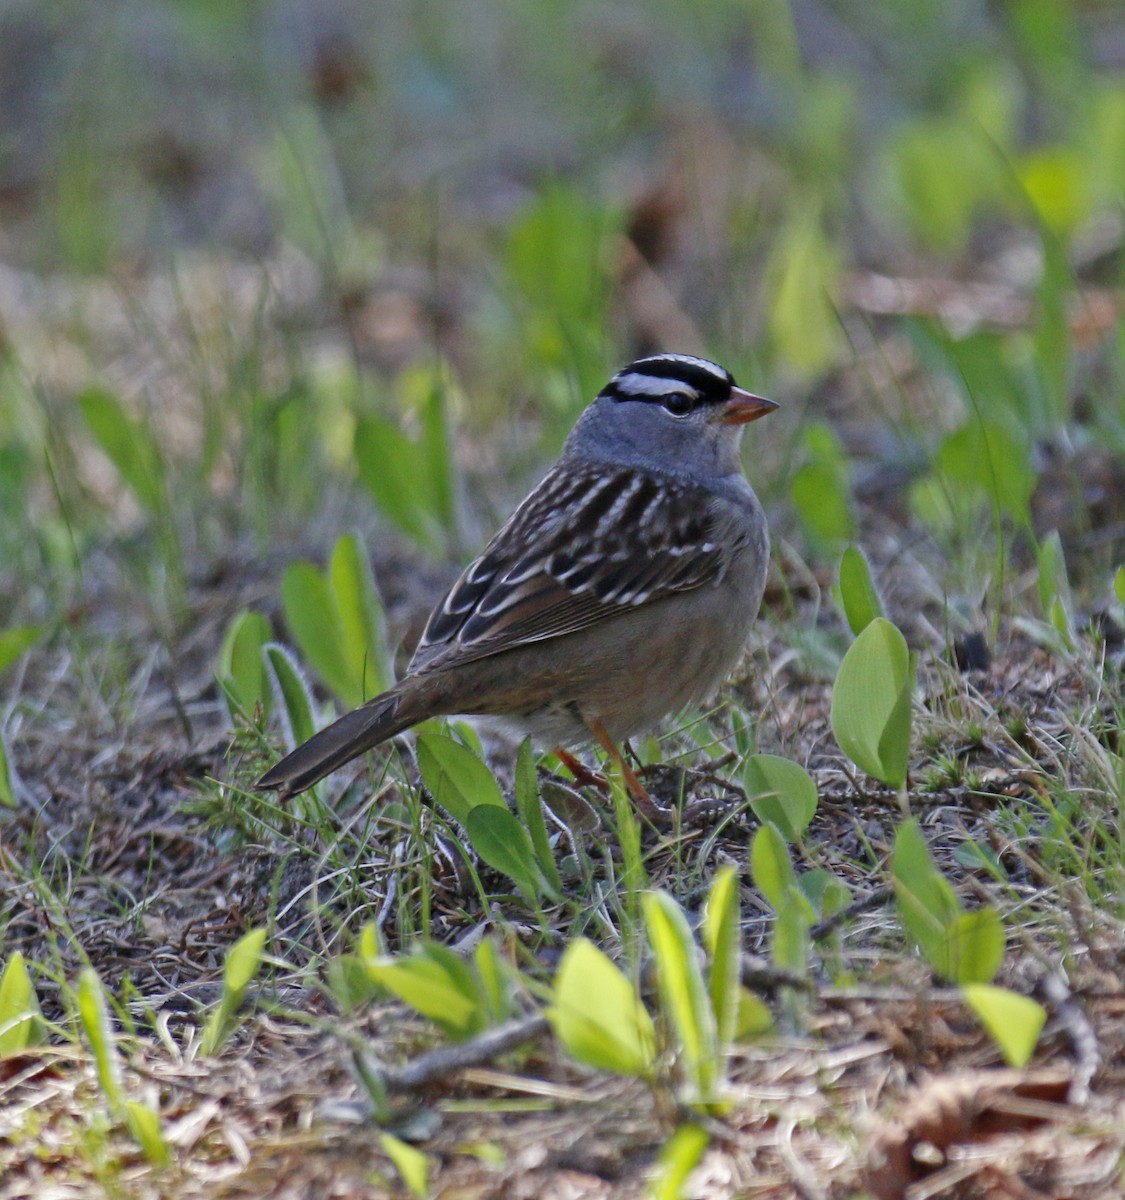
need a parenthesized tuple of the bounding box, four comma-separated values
(258, 354, 777, 798)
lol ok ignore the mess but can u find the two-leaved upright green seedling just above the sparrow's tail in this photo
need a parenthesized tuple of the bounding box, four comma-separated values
(282, 534, 392, 708)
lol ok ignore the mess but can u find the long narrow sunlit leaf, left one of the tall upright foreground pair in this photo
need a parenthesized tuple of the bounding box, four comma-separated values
(640, 892, 721, 1103)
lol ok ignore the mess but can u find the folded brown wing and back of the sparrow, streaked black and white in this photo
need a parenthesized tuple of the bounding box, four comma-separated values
(410, 464, 723, 672)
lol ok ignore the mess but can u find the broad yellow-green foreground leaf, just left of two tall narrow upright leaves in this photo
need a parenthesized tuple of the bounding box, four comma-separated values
(547, 937, 656, 1079)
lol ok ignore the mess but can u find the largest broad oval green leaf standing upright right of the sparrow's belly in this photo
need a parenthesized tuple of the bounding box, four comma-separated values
(831, 617, 914, 790)
